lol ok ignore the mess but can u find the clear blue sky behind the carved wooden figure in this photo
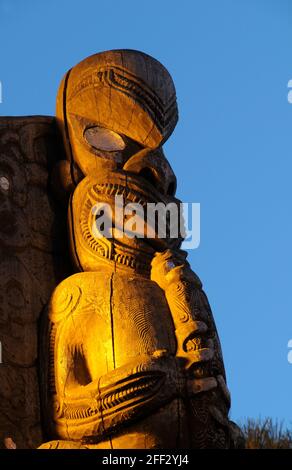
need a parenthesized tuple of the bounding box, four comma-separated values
(0, 0, 292, 424)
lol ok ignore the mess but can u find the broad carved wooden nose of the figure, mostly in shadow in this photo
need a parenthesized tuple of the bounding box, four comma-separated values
(123, 148, 176, 196)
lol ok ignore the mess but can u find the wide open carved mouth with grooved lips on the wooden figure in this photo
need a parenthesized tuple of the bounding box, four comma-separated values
(77, 175, 182, 277)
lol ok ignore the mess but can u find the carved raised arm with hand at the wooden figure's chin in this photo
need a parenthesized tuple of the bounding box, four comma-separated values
(151, 250, 228, 397)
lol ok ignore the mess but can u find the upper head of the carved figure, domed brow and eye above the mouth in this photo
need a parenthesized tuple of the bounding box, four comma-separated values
(57, 50, 178, 176)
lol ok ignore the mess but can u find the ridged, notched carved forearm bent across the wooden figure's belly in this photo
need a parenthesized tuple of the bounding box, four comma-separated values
(63, 372, 165, 420)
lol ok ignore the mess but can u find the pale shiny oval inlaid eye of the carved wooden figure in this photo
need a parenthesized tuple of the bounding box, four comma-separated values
(84, 126, 126, 152)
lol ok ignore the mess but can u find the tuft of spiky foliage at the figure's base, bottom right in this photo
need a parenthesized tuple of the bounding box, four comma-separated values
(241, 418, 292, 449)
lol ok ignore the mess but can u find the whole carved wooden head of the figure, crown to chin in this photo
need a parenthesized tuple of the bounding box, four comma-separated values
(57, 50, 180, 270)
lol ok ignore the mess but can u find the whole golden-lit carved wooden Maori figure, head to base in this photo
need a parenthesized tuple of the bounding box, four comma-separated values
(41, 50, 240, 448)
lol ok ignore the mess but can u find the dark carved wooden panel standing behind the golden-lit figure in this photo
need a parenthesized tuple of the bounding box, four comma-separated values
(0, 116, 68, 448)
